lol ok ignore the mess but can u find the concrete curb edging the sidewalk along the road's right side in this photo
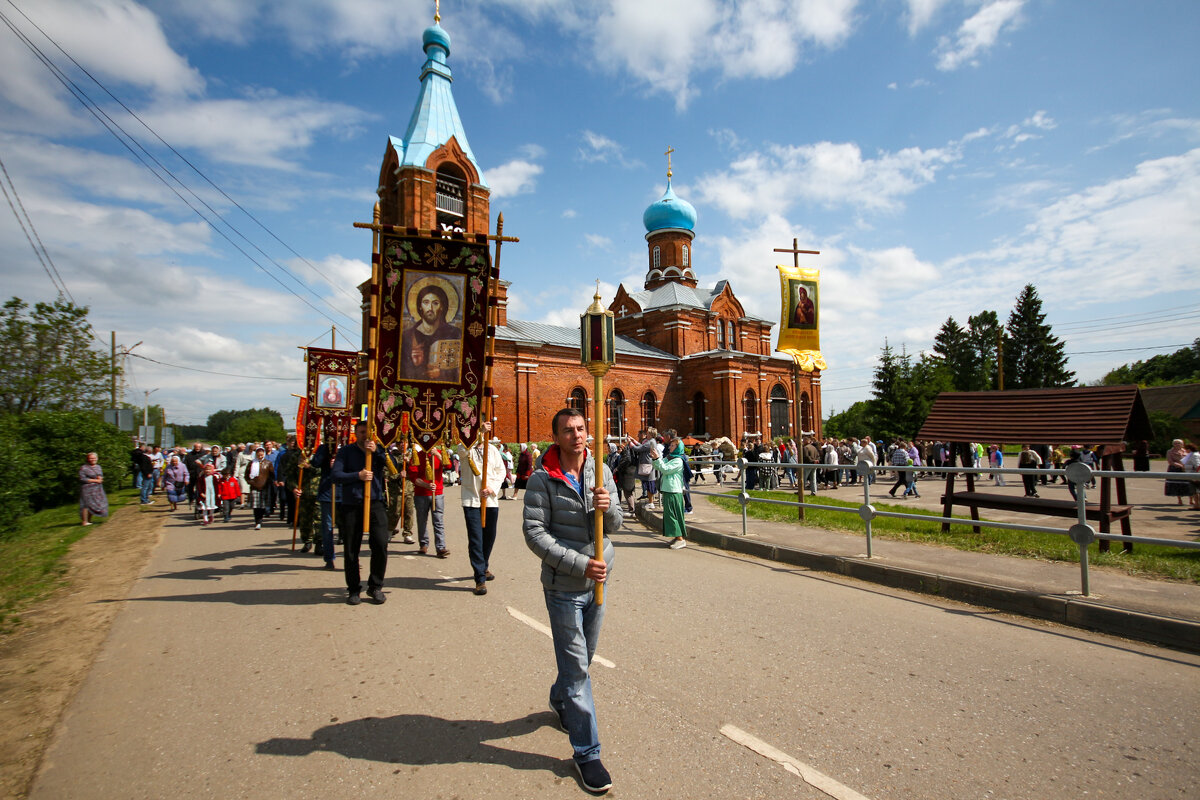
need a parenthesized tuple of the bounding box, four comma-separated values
(637, 506, 1200, 652)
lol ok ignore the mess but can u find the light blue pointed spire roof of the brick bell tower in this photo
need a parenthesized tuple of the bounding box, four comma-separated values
(389, 23, 487, 186)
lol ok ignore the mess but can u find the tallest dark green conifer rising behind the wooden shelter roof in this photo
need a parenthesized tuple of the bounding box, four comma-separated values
(1004, 283, 1075, 389)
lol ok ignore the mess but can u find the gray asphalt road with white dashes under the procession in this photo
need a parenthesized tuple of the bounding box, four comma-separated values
(31, 489, 1200, 800)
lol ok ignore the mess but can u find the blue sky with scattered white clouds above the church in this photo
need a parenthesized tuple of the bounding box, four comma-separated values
(0, 0, 1200, 425)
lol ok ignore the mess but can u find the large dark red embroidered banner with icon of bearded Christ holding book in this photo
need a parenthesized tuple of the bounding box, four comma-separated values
(374, 231, 491, 450)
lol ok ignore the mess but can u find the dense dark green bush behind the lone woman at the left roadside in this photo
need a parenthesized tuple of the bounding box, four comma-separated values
(0, 411, 132, 530)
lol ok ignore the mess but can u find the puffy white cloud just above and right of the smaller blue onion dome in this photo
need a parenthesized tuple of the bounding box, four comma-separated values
(696, 142, 959, 219)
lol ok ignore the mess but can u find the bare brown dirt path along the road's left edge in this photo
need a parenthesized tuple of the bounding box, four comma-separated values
(0, 500, 167, 800)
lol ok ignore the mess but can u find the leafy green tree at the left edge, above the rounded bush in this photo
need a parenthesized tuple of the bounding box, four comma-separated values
(0, 297, 113, 414)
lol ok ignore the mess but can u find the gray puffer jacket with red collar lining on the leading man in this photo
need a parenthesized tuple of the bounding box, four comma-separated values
(522, 445, 624, 591)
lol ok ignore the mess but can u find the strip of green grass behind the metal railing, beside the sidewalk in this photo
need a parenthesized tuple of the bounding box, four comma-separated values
(709, 492, 1200, 583)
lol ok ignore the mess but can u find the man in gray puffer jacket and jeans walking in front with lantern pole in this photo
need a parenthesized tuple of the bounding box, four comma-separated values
(522, 408, 623, 794)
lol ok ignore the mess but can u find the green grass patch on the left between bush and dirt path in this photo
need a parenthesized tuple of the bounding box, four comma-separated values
(0, 488, 138, 634)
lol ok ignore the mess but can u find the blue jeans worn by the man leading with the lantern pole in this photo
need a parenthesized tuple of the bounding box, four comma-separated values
(542, 587, 611, 764)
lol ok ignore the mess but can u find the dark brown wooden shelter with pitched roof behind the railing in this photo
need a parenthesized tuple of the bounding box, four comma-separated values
(917, 386, 1152, 552)
